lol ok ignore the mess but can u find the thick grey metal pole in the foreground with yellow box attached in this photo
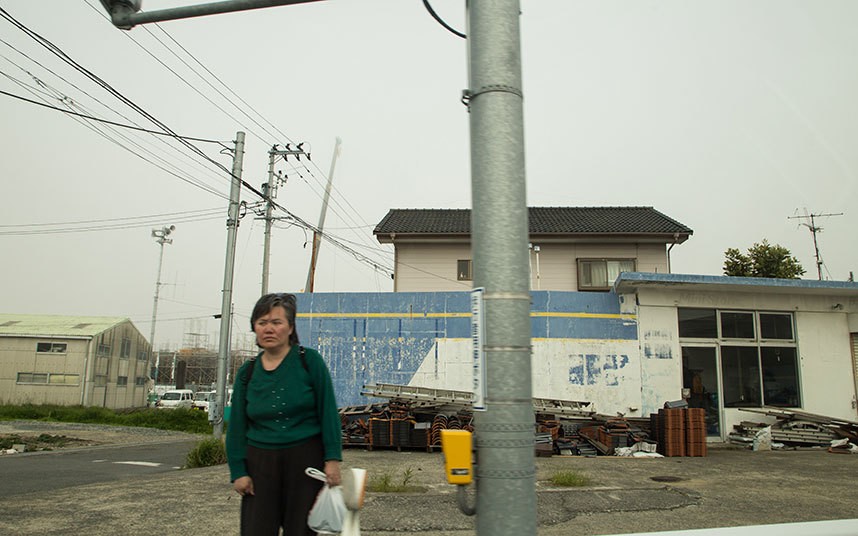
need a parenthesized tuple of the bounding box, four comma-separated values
(464, 0, 537, 536)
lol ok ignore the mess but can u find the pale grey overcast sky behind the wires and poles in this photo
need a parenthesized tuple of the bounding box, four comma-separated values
(0, 0, 858, 347)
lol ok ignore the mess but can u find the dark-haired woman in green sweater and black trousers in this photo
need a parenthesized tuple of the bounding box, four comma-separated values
(226, 293, 342, 536)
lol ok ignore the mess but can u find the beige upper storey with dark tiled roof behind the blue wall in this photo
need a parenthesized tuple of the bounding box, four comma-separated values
(373, 207, 693, 292)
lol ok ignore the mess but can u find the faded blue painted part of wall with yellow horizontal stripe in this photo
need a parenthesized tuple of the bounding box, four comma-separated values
(296, 291, 637, 406)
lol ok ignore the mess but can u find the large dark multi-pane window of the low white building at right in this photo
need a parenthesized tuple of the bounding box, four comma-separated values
(677, 308, 801, 408)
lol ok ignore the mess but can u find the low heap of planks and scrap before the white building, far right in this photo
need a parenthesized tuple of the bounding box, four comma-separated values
(729, 407, 858, 453)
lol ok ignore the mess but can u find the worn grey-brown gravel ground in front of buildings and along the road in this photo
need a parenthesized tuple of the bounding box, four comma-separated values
(0, 422, 858, 536)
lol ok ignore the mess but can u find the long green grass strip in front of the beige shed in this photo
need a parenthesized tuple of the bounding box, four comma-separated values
(0, 404, 212, 434)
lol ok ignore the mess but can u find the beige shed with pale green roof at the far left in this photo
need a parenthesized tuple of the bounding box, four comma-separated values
(0, 313, 150, 408)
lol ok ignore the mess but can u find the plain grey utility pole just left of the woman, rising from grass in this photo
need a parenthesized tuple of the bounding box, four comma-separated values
(209, 131, 244, 438)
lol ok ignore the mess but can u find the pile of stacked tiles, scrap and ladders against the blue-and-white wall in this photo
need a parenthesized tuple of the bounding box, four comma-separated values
(340, 383, 706, 456)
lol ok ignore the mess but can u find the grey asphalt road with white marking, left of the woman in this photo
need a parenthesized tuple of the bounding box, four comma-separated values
(0, 439, 198, 499)
